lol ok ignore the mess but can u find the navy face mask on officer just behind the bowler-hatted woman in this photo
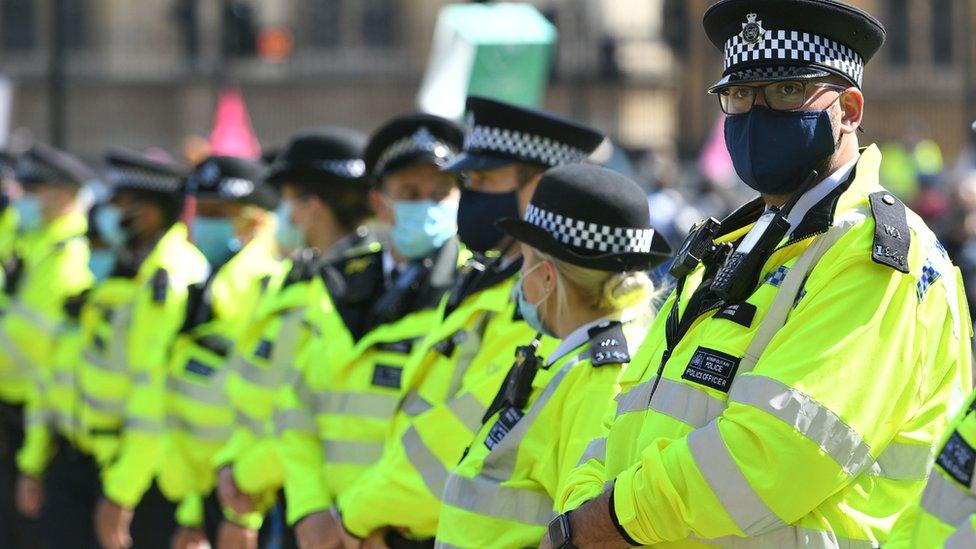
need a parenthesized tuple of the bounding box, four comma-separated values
(458, 188, 519, 253)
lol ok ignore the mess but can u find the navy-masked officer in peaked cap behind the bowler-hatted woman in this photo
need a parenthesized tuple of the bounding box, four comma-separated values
(338, 97, 603, 546)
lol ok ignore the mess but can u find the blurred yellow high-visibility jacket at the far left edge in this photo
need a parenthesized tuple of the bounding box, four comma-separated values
(0, 213, 94, 403)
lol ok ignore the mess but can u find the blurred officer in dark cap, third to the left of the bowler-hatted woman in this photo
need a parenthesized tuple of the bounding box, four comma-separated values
(214, 128, 380, 544)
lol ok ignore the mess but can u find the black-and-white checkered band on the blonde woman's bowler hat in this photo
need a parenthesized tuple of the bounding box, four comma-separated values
(525, 204, 654, 254)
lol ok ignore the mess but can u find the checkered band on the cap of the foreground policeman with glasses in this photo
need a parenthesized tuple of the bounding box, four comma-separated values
(725, 30, 864, 86)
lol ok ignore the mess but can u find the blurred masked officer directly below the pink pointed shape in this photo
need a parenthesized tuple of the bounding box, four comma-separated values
(143, 156, 278, 547)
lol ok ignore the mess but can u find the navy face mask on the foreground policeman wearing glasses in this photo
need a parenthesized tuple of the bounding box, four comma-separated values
(725, 105, 836, 195)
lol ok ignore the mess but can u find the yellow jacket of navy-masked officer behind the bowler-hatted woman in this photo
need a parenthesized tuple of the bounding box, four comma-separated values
(337, 262, 556, 539)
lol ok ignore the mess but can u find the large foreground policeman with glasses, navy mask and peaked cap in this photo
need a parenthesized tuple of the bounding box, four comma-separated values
(543, 0, 972, 547)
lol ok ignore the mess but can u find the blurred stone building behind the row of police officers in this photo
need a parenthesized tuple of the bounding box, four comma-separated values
(0, 0, 976, 165)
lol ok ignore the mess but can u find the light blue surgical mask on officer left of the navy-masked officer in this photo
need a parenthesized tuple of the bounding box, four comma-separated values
(391, 200, 457, 259)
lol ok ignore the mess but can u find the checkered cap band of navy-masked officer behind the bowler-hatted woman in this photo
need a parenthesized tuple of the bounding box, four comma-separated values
(464, 125, 589, 166)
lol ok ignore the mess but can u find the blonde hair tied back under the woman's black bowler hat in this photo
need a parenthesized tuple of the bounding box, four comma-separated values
(531, 248, 660, 325)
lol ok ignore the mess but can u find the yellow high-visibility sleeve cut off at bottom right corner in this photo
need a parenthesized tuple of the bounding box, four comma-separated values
(885, 393, 976, 549)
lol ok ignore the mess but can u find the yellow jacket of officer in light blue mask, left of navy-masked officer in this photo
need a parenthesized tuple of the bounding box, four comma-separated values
(276, 242, 465, 523)
